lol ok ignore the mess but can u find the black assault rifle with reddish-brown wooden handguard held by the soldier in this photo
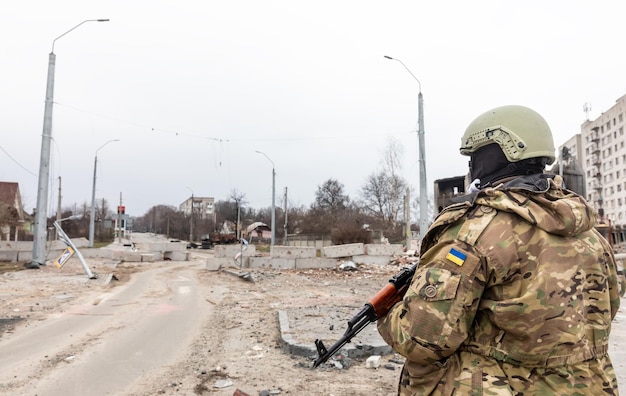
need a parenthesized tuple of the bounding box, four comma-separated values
(313, 264, 417, 368)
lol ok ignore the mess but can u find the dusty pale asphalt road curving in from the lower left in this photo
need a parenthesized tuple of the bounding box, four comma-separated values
(0, 263, 211, 396)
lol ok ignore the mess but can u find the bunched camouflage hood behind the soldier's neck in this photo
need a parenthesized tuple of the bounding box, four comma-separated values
(450, 174, 596, 236)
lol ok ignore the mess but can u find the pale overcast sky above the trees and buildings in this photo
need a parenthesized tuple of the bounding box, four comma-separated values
(0, 0, 626, 216)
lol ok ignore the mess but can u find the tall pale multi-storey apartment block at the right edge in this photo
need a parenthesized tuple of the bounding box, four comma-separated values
(581, 95, 626, 243)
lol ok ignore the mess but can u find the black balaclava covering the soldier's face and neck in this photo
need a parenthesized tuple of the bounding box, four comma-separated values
(469, 143, 546, 188)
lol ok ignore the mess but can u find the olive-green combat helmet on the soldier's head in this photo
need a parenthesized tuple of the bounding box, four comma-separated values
(460, 105, 555, 165)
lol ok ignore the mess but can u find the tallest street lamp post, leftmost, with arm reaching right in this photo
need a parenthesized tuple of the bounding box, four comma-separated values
(28, 19, 108, 268)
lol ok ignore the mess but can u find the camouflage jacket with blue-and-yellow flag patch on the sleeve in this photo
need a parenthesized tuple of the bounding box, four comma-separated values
(378, 175, 619, 396)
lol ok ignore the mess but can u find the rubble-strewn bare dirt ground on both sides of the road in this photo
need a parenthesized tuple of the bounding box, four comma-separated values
(0, 262, 402, 396)
